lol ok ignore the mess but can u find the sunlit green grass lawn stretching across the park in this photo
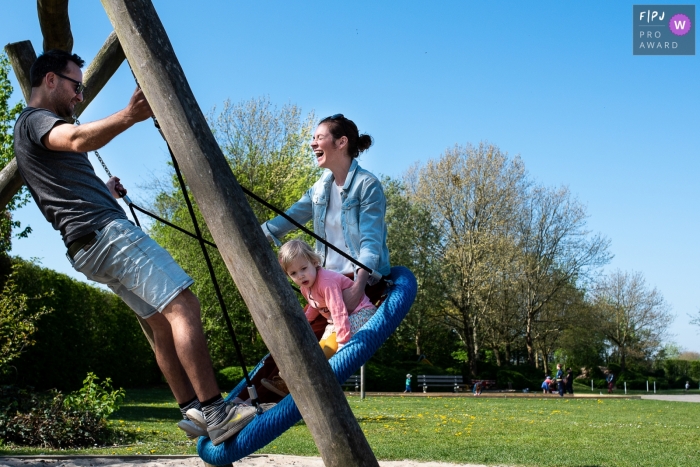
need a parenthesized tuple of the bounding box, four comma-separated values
(0, 389, 700, 467)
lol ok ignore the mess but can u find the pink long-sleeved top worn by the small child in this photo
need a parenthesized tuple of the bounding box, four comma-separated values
(301, 268, 372, 344)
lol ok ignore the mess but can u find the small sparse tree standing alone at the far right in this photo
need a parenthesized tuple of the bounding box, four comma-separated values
(592, 270, 673, 371)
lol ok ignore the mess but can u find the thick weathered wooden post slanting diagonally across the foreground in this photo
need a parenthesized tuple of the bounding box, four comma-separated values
(101, 0, 378, 467)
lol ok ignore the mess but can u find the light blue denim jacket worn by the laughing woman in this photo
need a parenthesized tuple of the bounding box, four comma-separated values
(262, 159, 391, 284)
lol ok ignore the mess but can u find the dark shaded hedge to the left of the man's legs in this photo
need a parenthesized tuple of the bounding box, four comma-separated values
(3, 258, 162, 391)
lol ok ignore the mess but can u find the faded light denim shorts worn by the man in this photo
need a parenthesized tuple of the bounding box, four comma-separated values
(66, 219, 194, 319)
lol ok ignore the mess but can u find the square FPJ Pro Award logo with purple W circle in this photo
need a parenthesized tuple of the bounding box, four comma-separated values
(632, 5, 695, 55)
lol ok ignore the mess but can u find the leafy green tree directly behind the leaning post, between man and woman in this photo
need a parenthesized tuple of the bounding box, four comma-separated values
(151, 98, 320, 368)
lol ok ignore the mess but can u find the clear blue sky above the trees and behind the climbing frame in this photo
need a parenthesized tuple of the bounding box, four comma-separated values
(0, 0, 700, 351)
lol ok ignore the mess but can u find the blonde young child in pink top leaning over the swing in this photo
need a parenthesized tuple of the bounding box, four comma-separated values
(278, 240, 377, 358)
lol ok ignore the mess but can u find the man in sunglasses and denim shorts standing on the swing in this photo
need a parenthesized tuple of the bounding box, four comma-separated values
(14, 50, 256, 445)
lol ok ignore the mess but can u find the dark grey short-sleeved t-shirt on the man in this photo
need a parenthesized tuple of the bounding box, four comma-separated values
(14, 107, 126, 246)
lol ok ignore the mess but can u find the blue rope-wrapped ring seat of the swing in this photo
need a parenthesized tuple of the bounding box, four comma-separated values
(197, 266, 417, 465)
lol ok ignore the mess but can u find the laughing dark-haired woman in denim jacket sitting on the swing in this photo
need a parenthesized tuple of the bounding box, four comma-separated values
(253, 114, 391, 402)
